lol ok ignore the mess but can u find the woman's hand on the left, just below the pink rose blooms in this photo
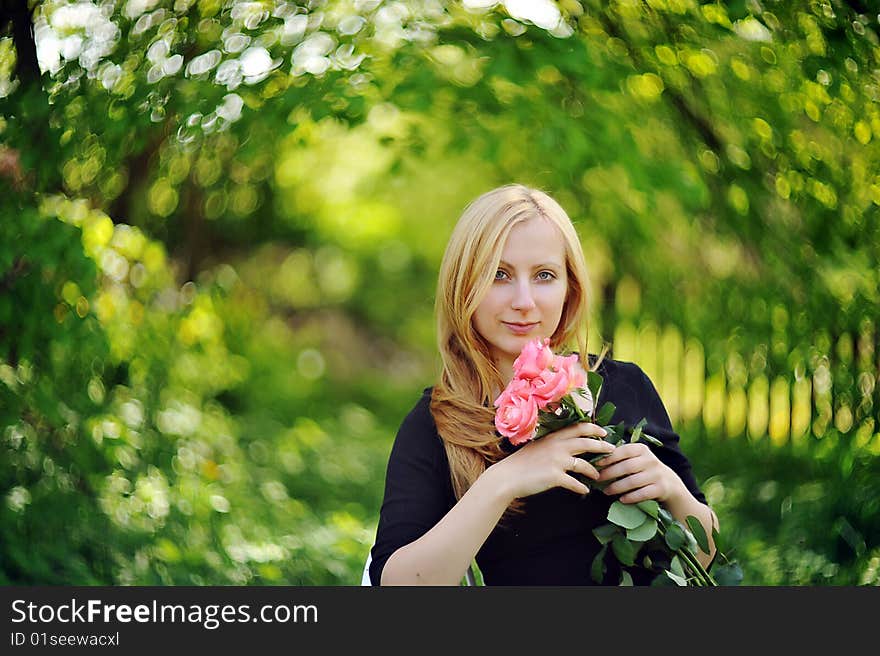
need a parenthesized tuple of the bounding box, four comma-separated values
(484, 422, 614, 501)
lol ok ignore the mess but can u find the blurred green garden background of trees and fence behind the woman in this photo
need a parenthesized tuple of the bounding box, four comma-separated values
(0, 0, 880, 585)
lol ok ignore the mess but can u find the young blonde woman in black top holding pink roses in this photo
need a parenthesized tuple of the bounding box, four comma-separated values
(369, 184, 717, 585)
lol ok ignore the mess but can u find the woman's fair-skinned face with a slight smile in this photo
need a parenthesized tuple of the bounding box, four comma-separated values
(473, 217, 568, 376)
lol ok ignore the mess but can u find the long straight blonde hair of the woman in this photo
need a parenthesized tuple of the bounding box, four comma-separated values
(431, 184, 607, 498)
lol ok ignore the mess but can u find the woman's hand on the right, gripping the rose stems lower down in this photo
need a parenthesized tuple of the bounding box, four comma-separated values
(596, 442, 689, 503)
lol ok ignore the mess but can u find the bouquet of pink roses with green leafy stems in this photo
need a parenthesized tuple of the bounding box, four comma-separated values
(495, 338, 742, 586)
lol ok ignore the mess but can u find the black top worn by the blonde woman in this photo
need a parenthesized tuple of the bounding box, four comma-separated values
(370, 356, 706, 585)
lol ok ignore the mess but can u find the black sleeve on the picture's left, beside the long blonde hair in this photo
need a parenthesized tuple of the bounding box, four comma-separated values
(370, 390, 455, 585)
